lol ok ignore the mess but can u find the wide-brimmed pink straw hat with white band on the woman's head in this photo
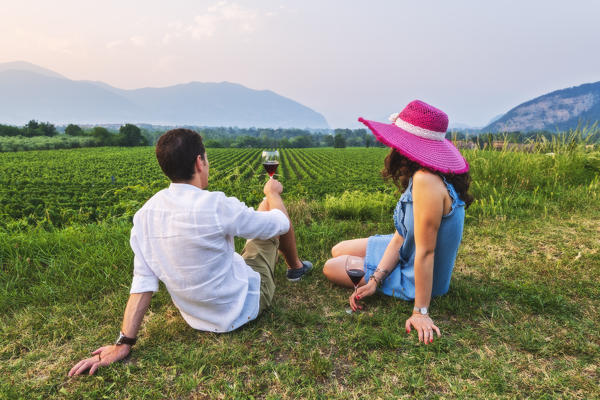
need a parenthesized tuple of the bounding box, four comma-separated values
(358, 100, 469, 174)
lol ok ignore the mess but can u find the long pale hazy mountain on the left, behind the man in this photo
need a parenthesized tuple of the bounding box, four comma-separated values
(0, 62, 328, 129)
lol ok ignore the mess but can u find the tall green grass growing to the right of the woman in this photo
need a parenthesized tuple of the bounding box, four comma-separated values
(448, 128, 600, 219)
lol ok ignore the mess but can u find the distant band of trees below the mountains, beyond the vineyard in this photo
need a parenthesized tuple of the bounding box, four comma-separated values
(0, 120, 600, 151)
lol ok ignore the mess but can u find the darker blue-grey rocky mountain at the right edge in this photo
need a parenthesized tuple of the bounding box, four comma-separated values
(482, 82, 600, 132)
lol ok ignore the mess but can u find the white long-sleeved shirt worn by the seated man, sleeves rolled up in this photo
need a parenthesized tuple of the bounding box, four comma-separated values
(130, 183, 290, 332)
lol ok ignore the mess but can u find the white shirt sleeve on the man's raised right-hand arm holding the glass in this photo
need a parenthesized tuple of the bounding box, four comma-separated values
(217, 196, 290, 240)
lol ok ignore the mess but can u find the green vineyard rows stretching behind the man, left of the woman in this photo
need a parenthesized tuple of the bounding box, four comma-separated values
(0, 147, 391, 226)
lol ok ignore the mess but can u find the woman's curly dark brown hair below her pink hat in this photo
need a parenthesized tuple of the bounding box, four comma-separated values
(381, 149, 474, 209)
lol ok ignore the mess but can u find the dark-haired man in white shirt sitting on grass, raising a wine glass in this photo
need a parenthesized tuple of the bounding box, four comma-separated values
(69, 129, 312, 376)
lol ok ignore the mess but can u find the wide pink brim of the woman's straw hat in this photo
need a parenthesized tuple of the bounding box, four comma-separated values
(358, 118, 469, 174)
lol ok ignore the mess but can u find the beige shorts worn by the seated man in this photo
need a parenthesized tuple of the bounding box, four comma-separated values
(242, 238, 279, 314)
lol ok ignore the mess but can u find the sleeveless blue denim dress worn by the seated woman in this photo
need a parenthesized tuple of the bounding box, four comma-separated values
(365, 178, 465, 300)
